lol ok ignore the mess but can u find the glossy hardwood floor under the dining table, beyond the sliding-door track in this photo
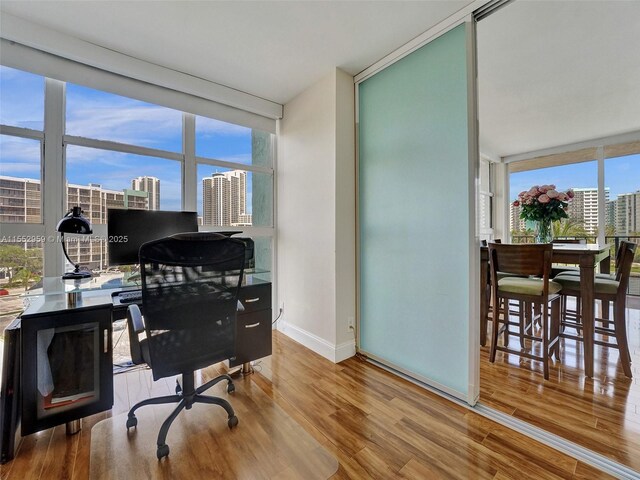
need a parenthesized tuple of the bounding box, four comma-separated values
(480, 300, 640, 475)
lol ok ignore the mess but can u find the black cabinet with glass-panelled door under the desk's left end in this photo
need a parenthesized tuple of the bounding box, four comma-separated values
(21, 305, 113, 435)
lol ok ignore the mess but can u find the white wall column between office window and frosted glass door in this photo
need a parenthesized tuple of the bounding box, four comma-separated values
(276, 69, 355, 362)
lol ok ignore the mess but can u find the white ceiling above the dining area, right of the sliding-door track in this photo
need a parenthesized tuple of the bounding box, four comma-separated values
(478, 0, 640, 156)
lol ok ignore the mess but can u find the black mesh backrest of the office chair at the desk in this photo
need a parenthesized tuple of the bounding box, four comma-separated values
(140, 233, 245, 380)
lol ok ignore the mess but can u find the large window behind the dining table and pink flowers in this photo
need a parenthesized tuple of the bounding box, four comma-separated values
(509, 147, 640, 295)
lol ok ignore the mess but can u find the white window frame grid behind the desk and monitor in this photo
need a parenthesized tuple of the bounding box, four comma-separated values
(0, 67, 276, 277)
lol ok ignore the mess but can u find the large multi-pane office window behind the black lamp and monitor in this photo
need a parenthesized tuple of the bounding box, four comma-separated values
(0, 67, 274, 280)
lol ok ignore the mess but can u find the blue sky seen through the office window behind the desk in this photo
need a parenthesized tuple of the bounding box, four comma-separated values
(0, 67, 252, 213)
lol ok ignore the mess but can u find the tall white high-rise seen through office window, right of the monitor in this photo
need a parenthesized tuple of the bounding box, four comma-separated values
(202, 170, 251, 226)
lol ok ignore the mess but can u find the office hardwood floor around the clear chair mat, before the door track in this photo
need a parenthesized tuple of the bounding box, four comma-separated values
(0, 332, 615, 480)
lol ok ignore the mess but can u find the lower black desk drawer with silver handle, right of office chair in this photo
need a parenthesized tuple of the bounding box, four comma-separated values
(231, 309, 271, 366)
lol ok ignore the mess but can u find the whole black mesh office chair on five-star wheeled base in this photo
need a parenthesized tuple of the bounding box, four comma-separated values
(127, 233, 245, 459)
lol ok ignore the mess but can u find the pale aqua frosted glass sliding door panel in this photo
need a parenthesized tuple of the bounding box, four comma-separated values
(358, 24, 477, 403)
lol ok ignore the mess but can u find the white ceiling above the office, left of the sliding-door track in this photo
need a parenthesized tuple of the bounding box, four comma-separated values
(0, 0, 472, 104)
